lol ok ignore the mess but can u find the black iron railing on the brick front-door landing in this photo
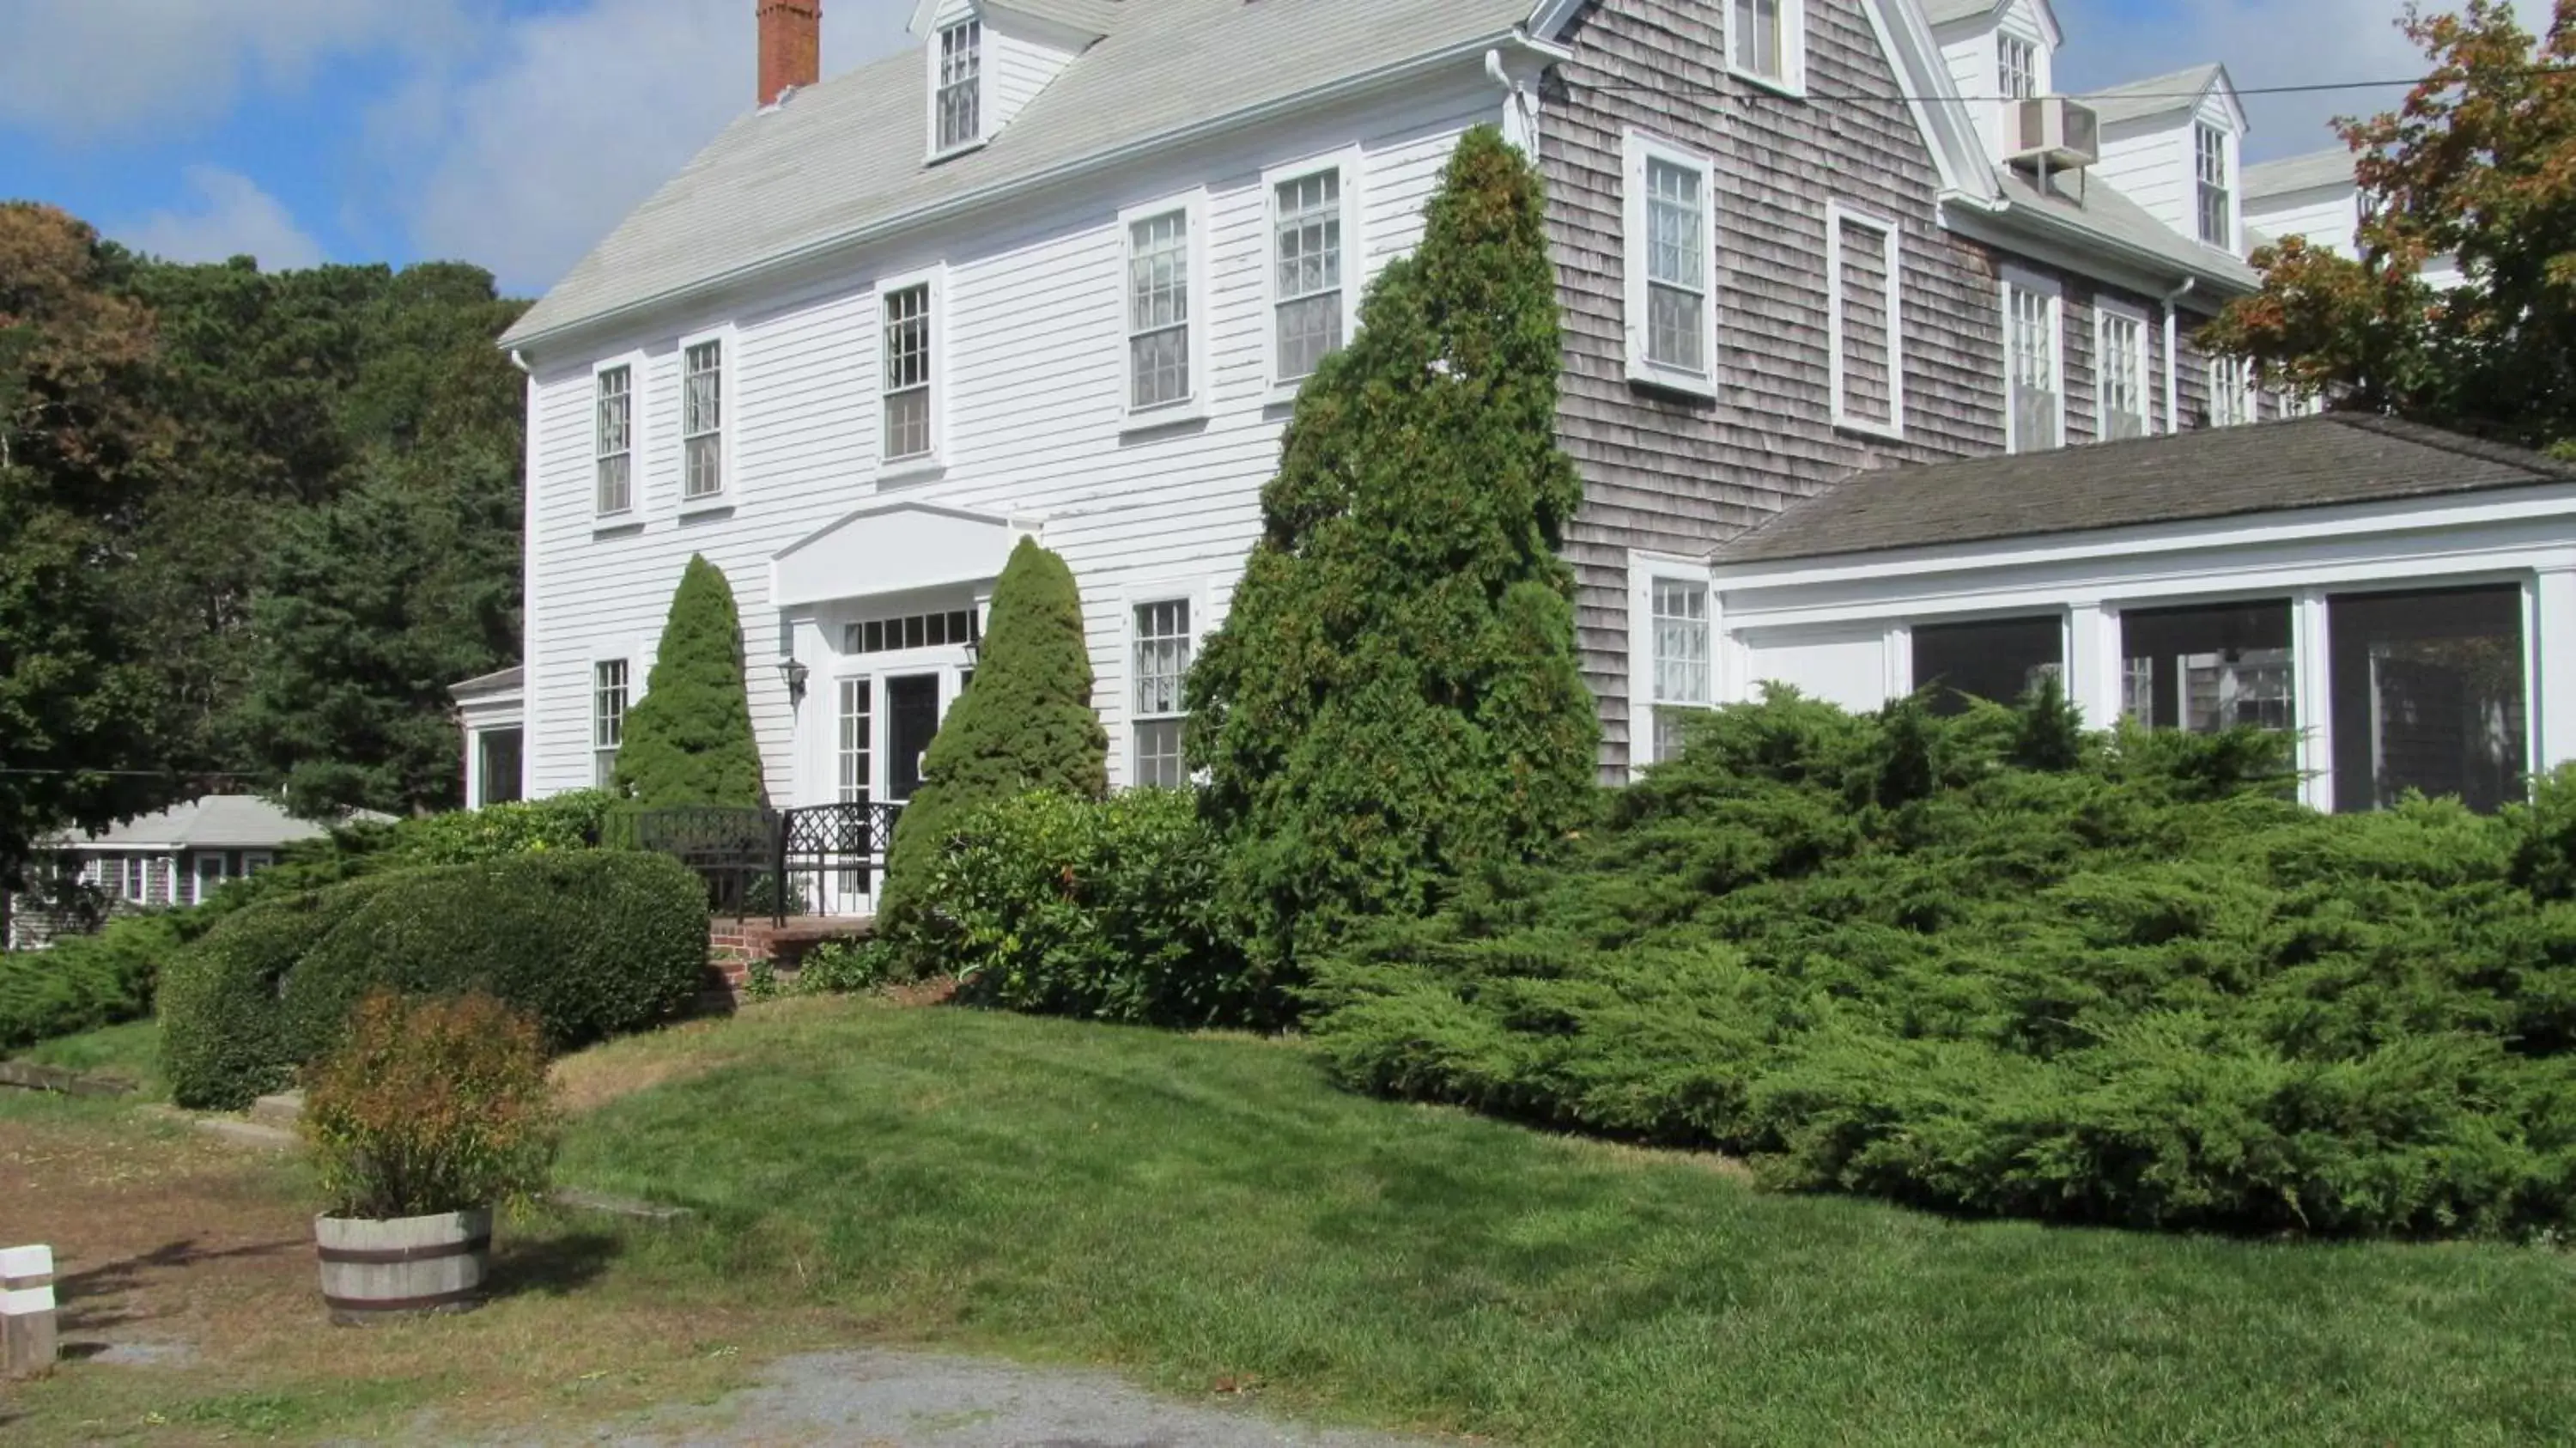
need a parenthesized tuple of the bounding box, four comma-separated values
(634, 801, 904, 925)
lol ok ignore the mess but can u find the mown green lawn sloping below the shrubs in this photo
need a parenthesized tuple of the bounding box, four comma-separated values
(564, 1002, 2576, 1445)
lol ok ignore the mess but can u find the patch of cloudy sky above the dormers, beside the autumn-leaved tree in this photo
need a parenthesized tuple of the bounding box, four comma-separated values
(2056, 0, 2535, 160)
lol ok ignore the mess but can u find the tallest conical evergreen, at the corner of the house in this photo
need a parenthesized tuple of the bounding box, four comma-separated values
(1190, 126, 1600, 974)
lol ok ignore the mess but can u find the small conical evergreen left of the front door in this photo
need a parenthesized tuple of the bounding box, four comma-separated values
(618, 557, 768, 809)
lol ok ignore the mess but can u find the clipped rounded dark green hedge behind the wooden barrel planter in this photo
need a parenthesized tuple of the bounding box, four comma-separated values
(160, 850, 706, 1108)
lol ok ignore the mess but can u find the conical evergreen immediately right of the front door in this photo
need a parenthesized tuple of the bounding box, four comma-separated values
(878, 538, 1110, 922)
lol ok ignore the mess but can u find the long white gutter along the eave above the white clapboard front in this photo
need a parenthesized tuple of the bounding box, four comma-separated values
(510, 26, 1574, 350)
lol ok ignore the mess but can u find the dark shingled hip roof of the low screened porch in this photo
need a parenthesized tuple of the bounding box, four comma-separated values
(1713, 412, 2576, 567)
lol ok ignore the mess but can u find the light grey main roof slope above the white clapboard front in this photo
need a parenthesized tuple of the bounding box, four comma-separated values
(502, 0, 1530, 345)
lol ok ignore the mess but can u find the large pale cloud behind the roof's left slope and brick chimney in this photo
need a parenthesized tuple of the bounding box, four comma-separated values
(368, 0, 912, 291)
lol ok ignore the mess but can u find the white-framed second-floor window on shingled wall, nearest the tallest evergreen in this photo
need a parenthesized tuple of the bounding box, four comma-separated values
(1625, 134, 1718, 394)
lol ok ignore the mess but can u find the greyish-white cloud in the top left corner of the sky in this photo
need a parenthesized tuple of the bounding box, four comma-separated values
(0, 0, 487, 139)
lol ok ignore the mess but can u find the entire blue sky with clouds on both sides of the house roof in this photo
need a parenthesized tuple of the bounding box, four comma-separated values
(0, 0, 2416, 294)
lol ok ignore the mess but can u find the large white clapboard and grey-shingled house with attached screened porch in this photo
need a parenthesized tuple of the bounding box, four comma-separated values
(461, 0, 2576, 881)
